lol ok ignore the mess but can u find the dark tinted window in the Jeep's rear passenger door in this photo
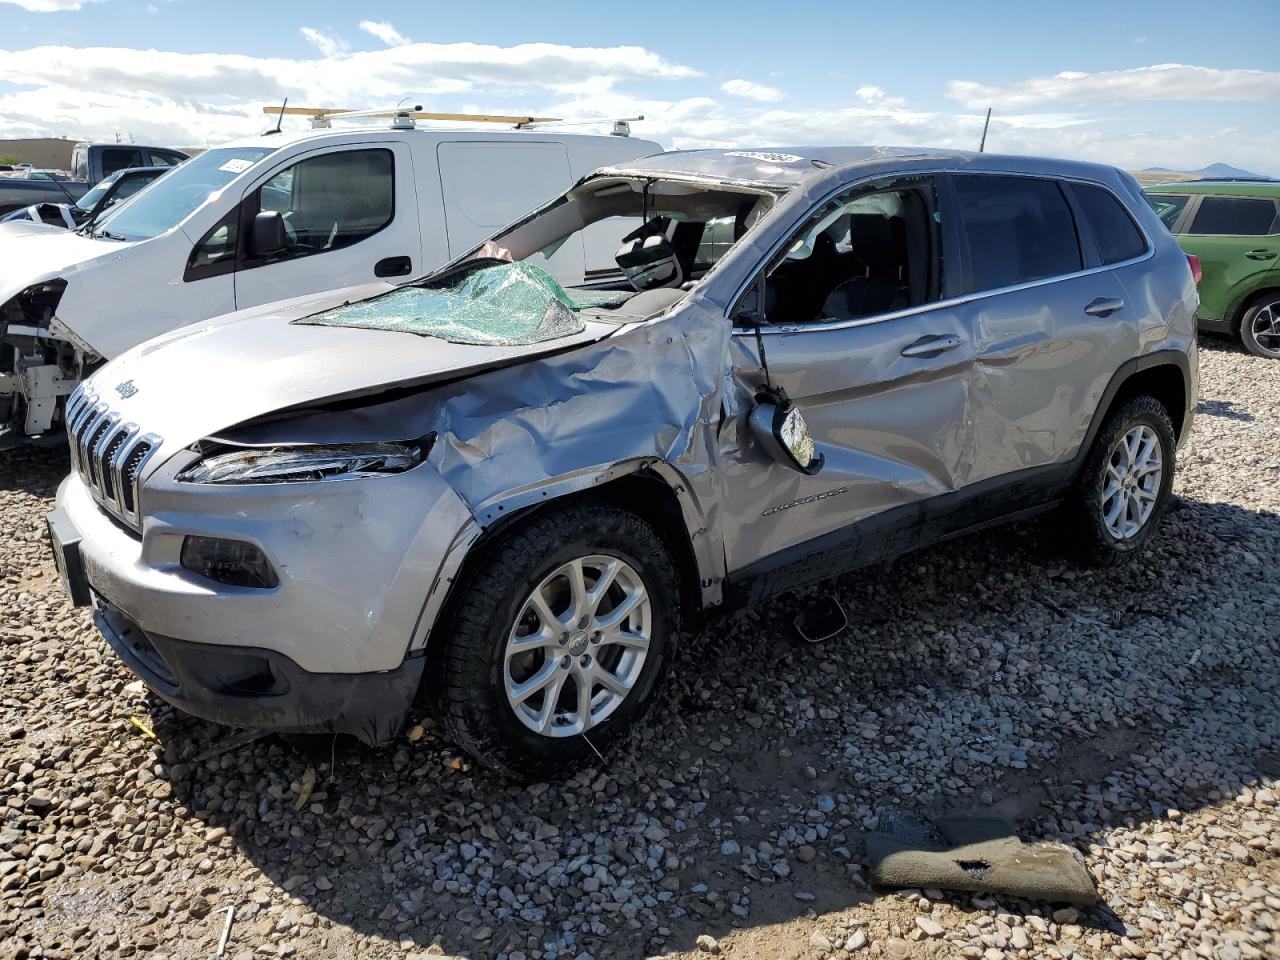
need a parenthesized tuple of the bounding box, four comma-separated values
(954, 174, 1083, 293)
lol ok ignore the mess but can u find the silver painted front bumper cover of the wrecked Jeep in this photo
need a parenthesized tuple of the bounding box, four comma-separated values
(55, 465, 476, 673)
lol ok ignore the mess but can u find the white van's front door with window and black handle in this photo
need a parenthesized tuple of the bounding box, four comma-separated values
(236, 142, 422, 310)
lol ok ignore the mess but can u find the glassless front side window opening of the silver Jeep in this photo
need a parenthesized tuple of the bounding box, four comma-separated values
(764, 179, 941, 324)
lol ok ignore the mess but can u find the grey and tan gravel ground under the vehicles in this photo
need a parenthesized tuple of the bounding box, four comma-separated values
(0, 340, 1280, 960)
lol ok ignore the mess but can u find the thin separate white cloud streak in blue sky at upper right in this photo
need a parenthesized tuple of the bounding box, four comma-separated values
(947, 63, 1280, 110)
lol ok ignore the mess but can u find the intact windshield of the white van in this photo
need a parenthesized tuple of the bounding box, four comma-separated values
(90, 147, 274, 241)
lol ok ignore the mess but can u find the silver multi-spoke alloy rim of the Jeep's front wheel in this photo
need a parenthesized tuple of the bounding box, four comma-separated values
(503, 554, 652, 737)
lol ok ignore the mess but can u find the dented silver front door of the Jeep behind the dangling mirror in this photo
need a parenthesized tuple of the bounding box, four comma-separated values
(721, 176, 974, 593)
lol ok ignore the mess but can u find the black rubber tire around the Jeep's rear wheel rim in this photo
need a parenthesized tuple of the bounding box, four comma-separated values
(1057, 397, 1178, 567)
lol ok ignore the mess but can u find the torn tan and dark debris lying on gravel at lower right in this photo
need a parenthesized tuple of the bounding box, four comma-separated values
(867, 812, 1098, 906)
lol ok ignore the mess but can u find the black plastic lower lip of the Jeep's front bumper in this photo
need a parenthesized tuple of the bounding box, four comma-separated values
(93, 596, 425, 746)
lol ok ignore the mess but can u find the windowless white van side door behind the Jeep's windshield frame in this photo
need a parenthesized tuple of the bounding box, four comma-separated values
(436, 140, 582, 283)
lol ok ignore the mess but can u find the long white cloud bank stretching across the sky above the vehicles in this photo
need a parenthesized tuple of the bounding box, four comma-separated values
(0, 44, 1280, 174)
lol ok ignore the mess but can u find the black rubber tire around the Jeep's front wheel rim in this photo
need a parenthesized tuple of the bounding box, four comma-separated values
(426, 502, 680, 780)
